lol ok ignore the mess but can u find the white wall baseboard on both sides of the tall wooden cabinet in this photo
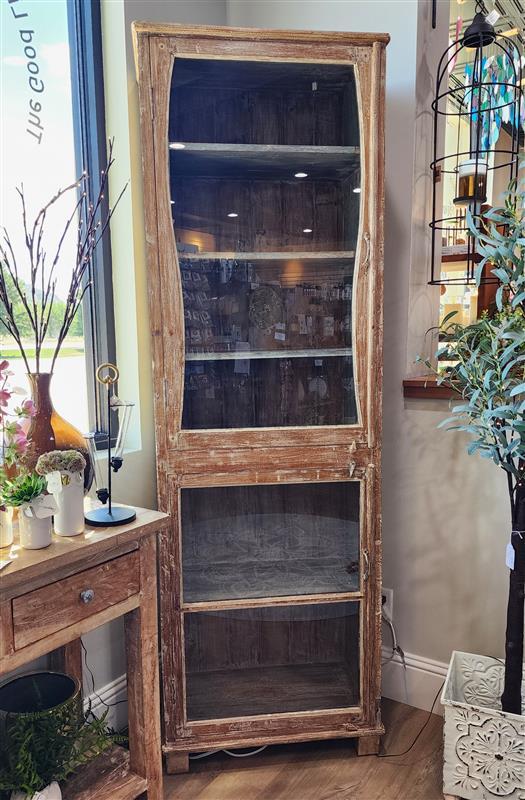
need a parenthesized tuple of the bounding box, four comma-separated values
(85, 647, 448, 730)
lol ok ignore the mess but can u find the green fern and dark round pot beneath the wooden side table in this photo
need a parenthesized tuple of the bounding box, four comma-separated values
(0, 672, 115, 800)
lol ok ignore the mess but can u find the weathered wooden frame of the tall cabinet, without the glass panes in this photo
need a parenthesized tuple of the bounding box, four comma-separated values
(133, 23, 389, 771)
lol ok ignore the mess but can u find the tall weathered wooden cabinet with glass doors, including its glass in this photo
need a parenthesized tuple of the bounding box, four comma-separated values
(134, 23, 388, 771)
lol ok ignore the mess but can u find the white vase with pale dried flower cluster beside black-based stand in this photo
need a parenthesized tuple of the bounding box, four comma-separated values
(36, 450, 86, 536)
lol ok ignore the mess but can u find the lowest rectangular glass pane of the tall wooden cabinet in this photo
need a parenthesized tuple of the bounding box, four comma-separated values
(184, 602, 359, 720)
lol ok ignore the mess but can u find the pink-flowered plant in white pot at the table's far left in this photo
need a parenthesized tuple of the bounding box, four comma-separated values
(0, 361, 34, 548)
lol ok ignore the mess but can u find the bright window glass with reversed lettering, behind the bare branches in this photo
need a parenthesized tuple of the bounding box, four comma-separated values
(0, 0, 89, 431)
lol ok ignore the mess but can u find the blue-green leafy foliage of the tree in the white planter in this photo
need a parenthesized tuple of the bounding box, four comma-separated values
(418, 162, 525, 516)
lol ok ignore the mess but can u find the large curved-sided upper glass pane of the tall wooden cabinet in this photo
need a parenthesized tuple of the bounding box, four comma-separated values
(169, 59, 360, 429)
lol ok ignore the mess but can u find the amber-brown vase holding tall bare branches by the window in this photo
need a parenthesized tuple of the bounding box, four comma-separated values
(0, 140, 126, 489)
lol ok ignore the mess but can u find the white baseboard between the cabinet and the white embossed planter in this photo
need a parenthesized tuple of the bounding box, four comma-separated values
(381, 647, 448, 714)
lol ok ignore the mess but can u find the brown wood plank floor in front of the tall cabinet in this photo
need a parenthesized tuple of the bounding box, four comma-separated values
(165, 700, 443, 800)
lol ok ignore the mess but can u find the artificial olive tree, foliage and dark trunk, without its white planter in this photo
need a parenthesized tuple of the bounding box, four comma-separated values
(425, 170, 525, 714)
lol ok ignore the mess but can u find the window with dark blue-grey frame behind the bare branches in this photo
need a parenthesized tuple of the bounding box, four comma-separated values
(0, 0, 115, 432)
